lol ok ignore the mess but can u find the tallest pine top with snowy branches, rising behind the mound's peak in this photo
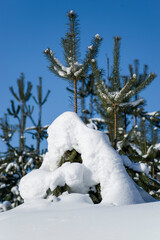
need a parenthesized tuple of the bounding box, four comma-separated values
(44, 10, 102, 113)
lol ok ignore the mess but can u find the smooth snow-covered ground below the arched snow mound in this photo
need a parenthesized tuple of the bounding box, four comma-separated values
(0, 194, 160, 240)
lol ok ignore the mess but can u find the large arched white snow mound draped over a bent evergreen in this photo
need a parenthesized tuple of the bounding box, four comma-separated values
(20, 112, 154, 205)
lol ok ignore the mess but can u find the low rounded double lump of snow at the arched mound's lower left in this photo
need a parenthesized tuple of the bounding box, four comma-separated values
(19, 162, 96, 200)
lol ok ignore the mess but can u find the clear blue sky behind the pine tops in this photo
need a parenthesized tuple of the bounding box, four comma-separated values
(0, 0, 160, 149)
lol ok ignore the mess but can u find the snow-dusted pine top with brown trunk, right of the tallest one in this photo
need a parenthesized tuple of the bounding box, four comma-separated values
(92, 37, 156, 149)
